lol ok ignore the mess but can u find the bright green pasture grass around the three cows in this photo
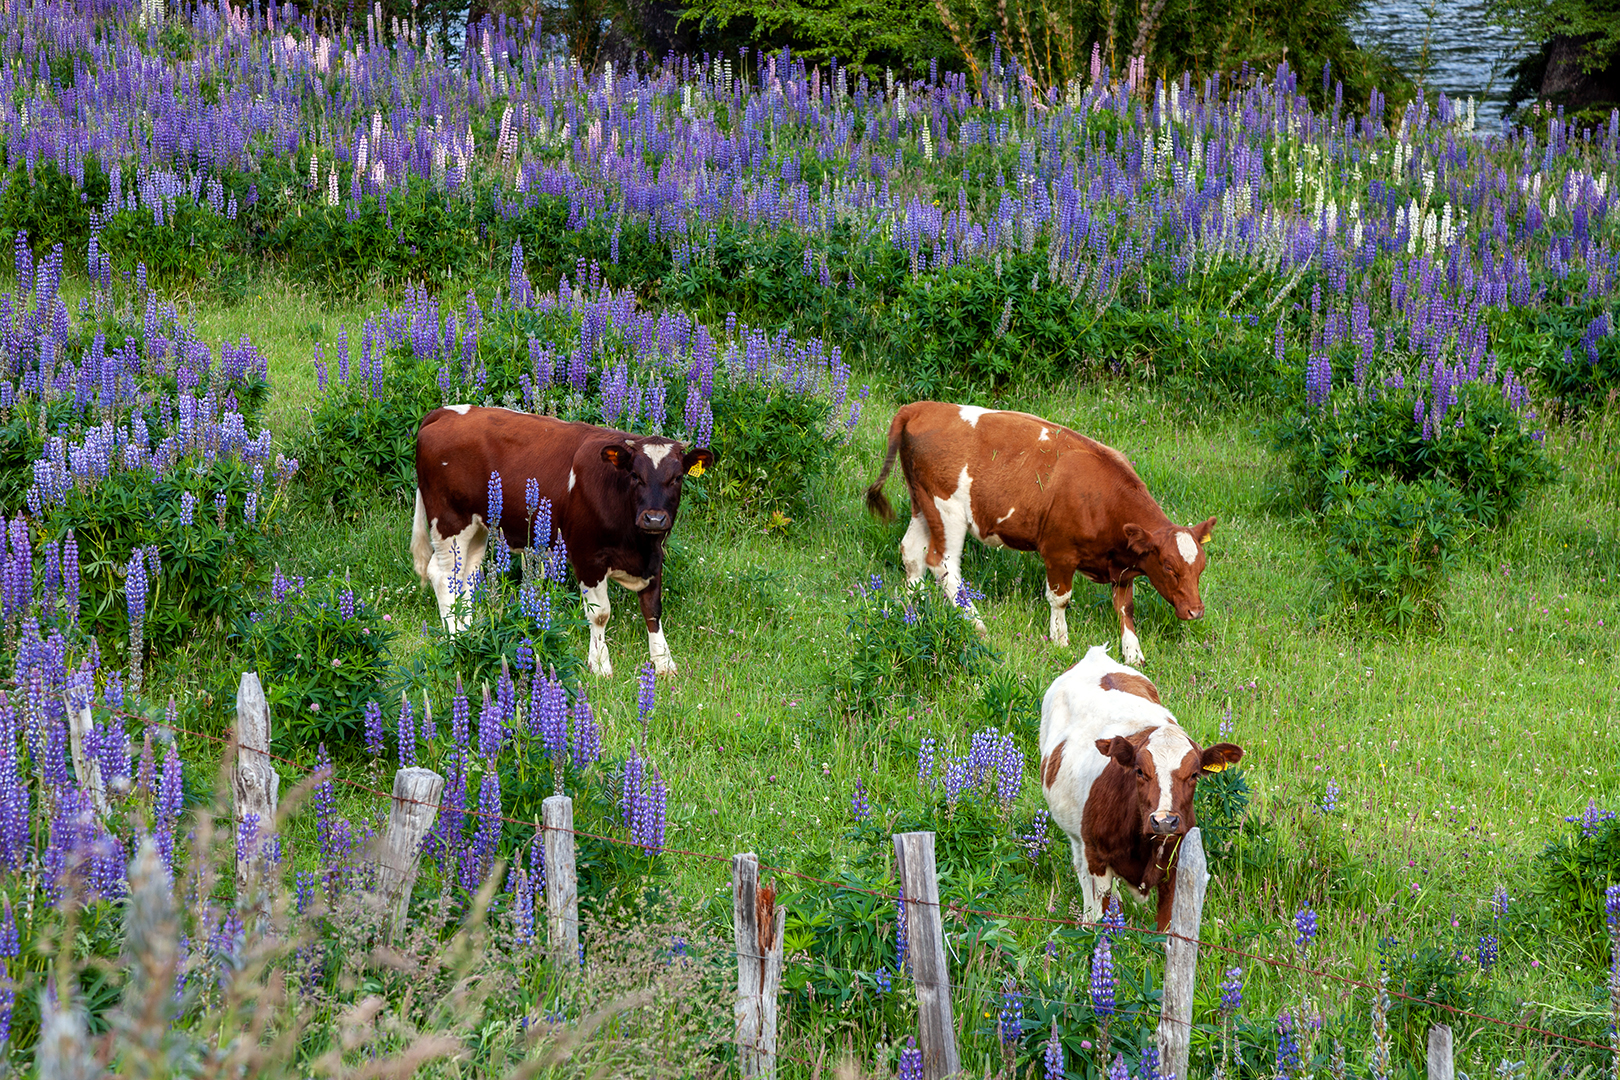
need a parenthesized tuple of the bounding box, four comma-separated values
(126, 281, 1620, 1075)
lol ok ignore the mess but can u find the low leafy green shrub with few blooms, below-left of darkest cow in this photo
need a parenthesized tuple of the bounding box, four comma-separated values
(235, 567, 394, 748)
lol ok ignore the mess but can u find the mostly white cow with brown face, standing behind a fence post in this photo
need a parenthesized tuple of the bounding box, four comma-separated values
(1040, 644, 1243, 931)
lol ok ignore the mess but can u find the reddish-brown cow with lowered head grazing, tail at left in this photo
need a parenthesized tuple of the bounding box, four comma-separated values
(867, 402, 1215, 664)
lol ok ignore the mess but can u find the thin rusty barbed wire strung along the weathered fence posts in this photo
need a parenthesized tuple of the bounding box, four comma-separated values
(85, 709, 1614, 1064)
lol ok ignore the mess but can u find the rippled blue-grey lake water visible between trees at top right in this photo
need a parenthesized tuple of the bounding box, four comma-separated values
(1351, 0, 1526, 131)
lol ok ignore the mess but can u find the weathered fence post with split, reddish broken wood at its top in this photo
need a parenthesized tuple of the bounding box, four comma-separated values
(731, 852, 787, 1080)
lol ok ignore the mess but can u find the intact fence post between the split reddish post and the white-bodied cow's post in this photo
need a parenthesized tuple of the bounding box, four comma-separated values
(894, 832, 962, 1080)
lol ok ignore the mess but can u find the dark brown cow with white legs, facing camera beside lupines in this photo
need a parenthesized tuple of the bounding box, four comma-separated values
(410, 405, 714, 675)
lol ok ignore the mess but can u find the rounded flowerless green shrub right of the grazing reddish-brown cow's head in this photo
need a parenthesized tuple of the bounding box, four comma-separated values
(1322, 476, 1468, 628)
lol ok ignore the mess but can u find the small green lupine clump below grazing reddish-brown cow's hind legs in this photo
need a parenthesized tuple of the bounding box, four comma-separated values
(836, 575, 1000, 712)
